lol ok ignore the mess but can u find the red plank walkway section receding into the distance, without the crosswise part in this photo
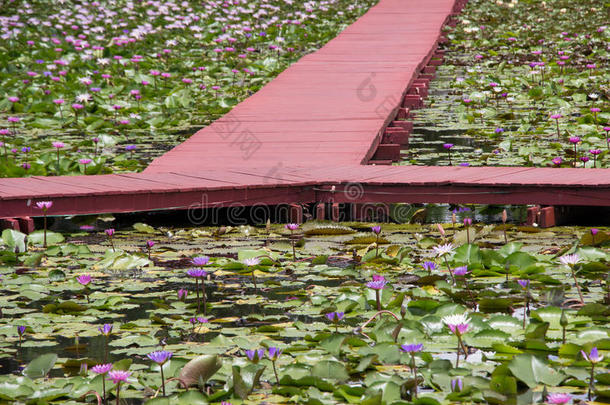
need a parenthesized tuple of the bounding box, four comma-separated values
(146, 0, 455, 173)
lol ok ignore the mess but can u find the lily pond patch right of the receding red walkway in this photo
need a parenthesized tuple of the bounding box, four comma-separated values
(402, 0, 610, 168)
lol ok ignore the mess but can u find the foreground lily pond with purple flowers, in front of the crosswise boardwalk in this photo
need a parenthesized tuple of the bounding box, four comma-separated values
(0, 211, 610, 404)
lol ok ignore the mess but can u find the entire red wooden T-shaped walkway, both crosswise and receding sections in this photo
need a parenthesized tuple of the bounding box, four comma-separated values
(0, 0, 610, 218)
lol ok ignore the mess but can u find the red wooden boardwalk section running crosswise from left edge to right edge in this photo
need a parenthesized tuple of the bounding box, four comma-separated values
(0, 166, 610, 217)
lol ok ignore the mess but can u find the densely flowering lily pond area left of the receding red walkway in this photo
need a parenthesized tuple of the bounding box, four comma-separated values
(0, 0, 376, 177)
